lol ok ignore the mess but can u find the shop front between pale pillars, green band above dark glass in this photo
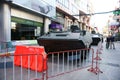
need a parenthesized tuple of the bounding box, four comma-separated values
(11, 17, 43, 40)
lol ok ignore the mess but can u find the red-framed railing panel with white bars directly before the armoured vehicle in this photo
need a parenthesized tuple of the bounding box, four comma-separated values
(47, 49, 94, 78)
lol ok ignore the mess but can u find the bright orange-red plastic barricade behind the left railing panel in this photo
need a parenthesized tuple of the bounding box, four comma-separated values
(14, 45, 47, 72)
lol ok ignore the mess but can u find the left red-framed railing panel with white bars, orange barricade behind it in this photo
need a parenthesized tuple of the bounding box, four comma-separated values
(0, 46, 47, 80)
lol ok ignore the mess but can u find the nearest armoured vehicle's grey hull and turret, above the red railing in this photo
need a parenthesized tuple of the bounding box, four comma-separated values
(37, 25, 92, 52)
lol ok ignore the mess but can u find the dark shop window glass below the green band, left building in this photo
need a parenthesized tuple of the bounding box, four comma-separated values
(11, 22, 40, 40)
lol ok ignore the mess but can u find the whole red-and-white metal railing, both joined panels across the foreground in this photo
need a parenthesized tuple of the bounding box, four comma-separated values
(0, 42, 97, 80)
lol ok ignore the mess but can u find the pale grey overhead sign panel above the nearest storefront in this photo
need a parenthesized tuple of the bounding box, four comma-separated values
(12, 0, 56, 17)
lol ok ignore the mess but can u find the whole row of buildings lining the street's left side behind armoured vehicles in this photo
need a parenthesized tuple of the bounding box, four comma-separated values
(0, 0, 92, 48)
